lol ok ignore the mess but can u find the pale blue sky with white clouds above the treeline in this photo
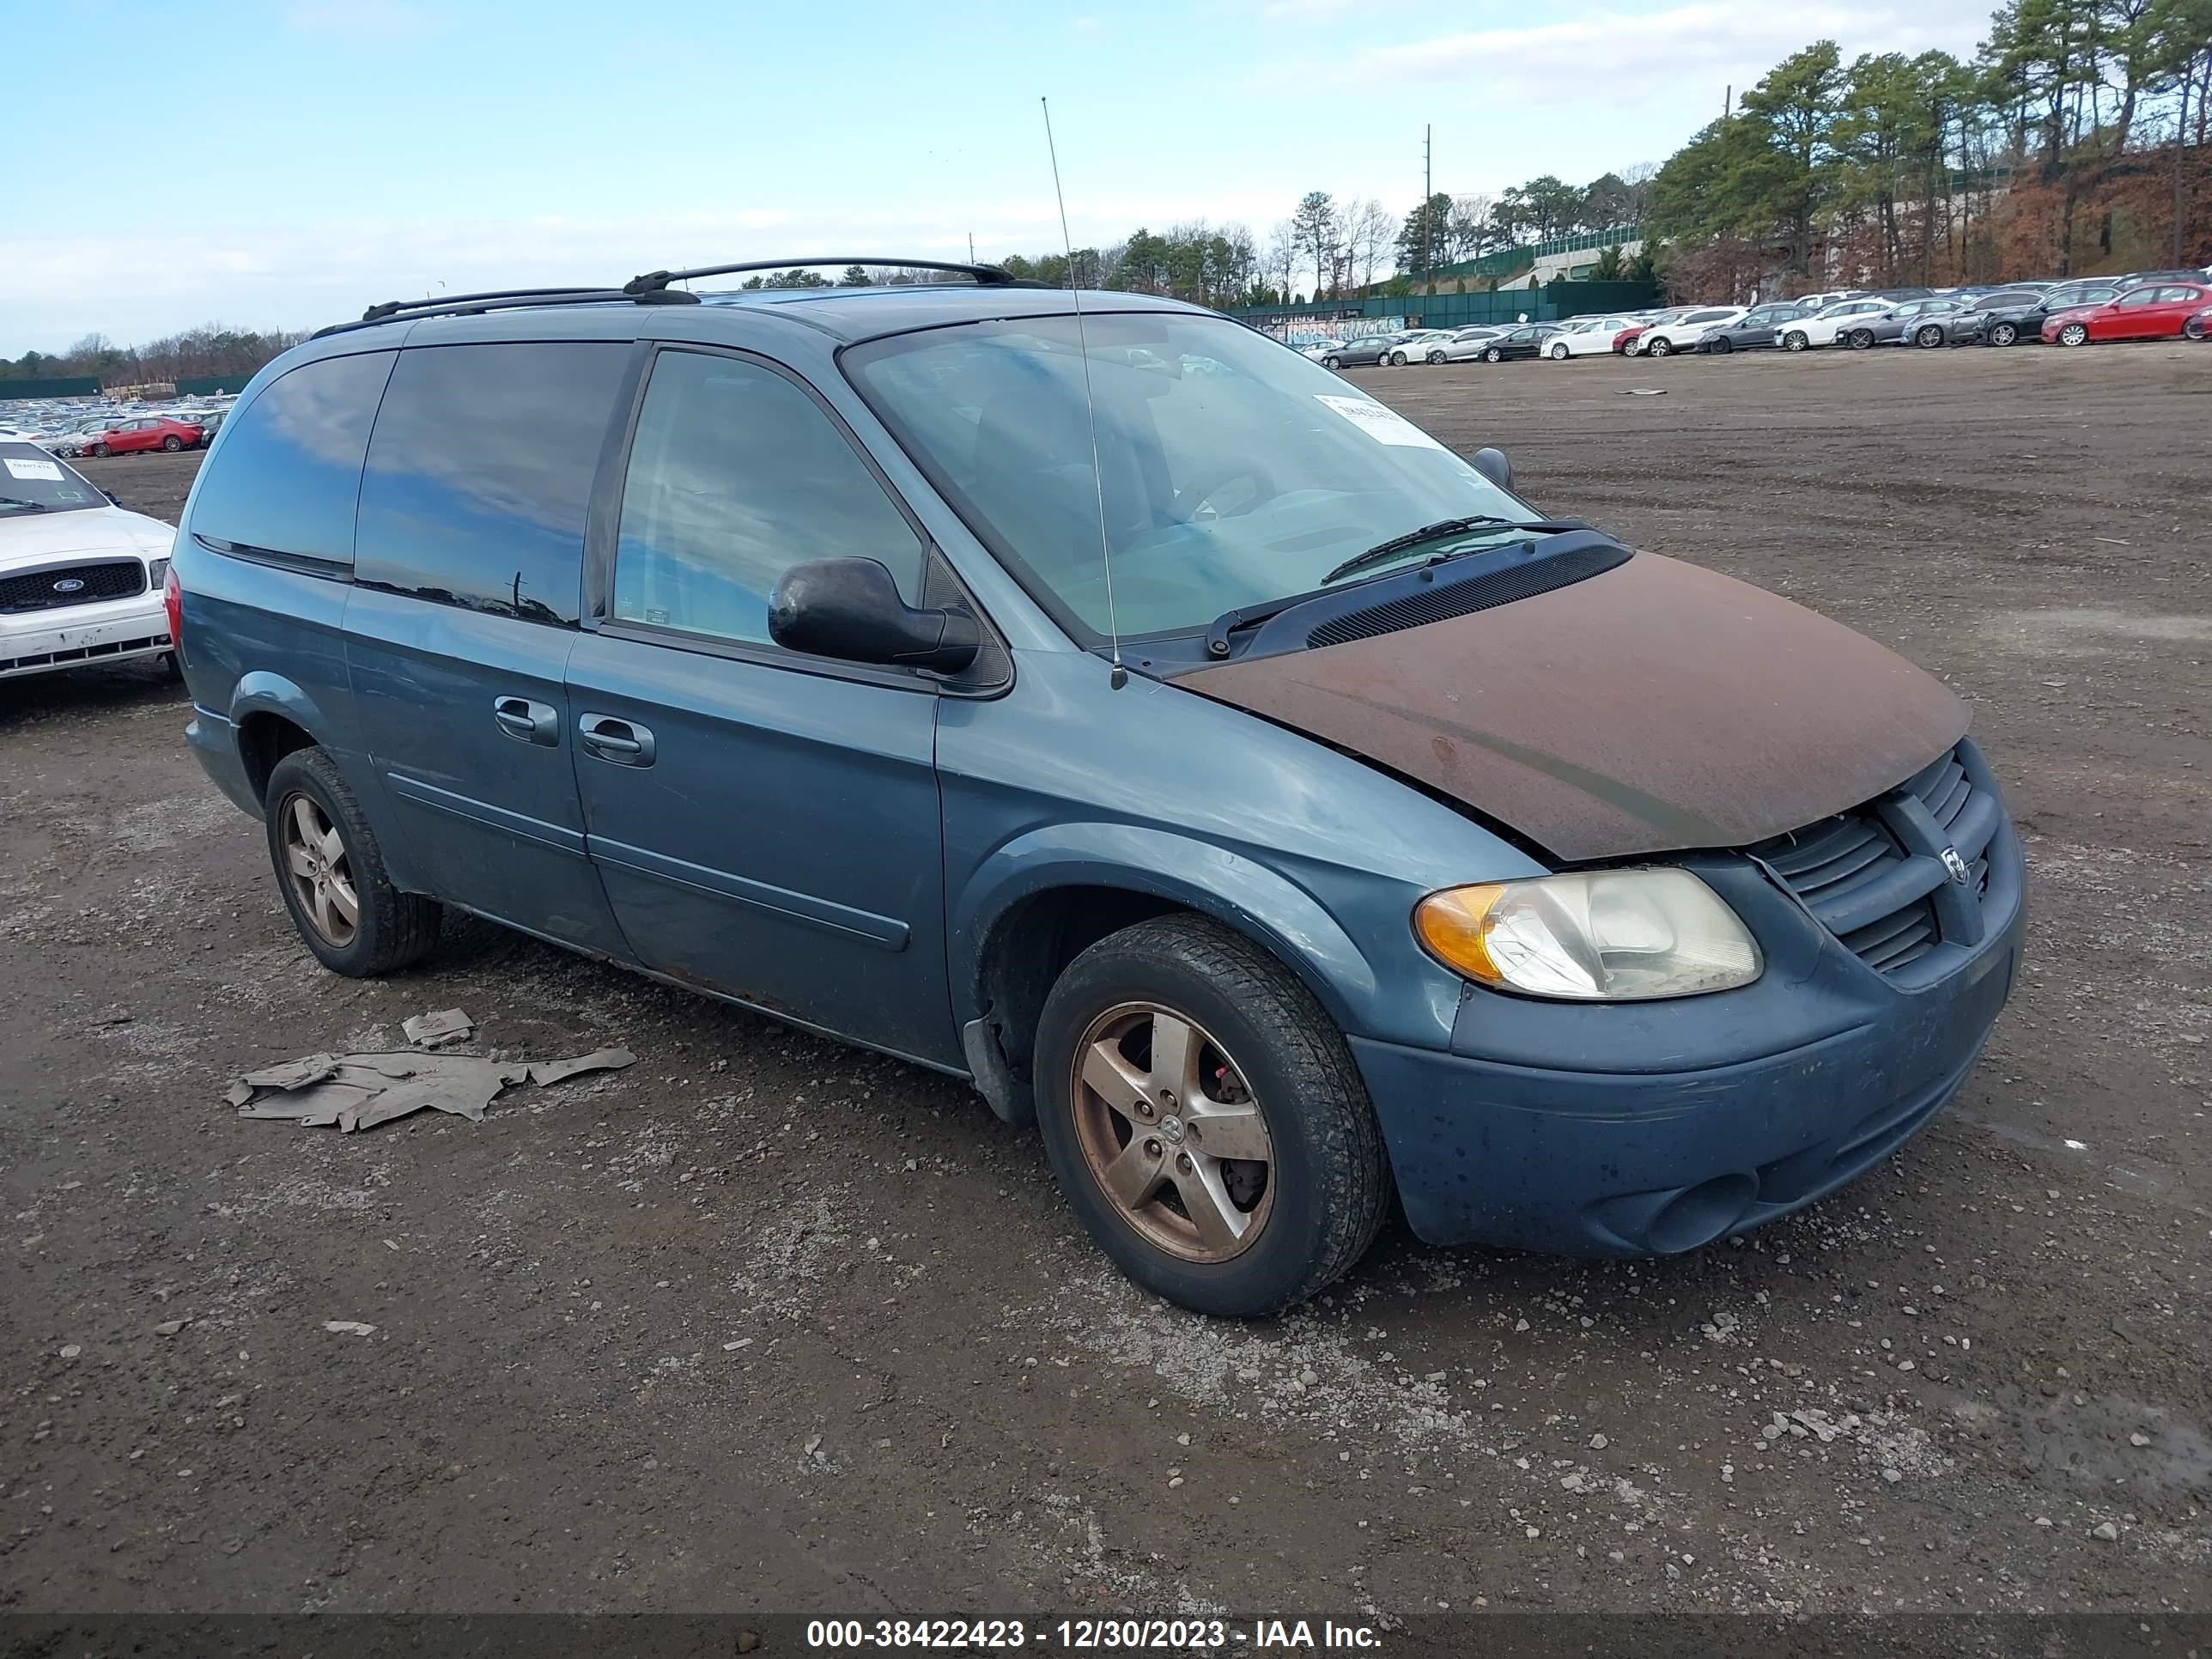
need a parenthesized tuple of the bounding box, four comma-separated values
(0, 0, 1989, 358)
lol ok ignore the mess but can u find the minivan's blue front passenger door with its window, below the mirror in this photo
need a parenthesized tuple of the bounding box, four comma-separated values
(566, 347, 960, 1066)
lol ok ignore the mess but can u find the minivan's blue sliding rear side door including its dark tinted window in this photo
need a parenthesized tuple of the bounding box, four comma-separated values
(345, 341, 633, 956)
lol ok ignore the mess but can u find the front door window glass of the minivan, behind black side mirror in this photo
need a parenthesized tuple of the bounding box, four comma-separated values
(615, 352, 925, 646)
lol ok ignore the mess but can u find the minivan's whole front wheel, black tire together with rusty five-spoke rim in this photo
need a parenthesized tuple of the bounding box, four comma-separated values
(1036, 915, 1391, 1318)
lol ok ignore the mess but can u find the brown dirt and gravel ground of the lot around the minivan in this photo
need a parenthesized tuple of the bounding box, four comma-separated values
(0, 345, 2212, 1650)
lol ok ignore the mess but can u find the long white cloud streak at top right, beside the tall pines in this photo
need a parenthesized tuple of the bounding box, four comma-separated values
(1265, 0, 1989, 101)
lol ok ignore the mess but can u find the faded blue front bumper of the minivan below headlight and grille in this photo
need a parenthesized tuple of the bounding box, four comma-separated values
(1352, 825, 2027, 1256)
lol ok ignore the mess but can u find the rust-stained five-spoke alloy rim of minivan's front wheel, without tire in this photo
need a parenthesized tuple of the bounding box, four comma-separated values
(1068, 1002, 1274, 1261)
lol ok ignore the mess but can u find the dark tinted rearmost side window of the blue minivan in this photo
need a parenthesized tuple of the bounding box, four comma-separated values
(192, 352, 398, 564)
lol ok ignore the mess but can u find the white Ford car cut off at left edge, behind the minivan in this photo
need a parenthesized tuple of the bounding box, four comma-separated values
(0, 442, 177, 679)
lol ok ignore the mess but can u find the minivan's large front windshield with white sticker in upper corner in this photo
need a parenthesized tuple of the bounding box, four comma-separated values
(842, 312, 1533, 644)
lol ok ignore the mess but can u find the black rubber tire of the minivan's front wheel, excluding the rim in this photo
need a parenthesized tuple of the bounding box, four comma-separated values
(1033, 915, 1391, 1318)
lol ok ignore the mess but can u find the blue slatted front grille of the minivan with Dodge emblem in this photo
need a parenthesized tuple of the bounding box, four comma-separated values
(1745, 741, 2002, 975)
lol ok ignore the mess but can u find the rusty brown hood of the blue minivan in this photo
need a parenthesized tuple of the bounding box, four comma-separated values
(1176, 553, 1966, 860)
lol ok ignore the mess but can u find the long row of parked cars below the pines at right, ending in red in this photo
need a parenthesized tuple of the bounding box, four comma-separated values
(1303, 270, 2212, 380)
